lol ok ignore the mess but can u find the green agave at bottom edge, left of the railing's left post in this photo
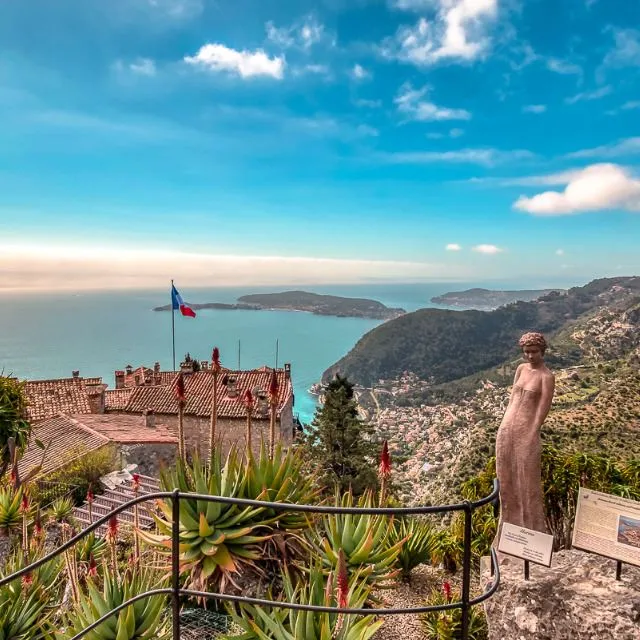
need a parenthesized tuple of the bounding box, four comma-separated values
(58, 570, 171, 640)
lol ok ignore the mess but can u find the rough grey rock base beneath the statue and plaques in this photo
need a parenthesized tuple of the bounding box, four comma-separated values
(481, 550, 640, 640)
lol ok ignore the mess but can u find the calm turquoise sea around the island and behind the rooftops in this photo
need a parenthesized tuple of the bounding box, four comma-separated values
(0, 282, 568, 423)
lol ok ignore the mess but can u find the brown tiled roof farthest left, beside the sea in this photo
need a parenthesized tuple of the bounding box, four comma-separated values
(25, 378, 102, 422)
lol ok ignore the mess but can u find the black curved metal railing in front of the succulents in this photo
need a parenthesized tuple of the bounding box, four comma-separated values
(0, 479, 500, 640)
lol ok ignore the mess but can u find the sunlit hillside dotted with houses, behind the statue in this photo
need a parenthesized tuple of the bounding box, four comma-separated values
(369, 291, 640, 504)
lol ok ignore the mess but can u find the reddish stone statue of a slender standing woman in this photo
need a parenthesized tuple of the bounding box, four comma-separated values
(496, 333, 555, 542)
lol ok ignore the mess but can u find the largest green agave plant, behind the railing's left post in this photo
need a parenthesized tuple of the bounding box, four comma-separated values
(138, 450, 271, 590)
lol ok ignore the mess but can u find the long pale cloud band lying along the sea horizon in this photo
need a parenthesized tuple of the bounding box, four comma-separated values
(0, 243, 470, 290)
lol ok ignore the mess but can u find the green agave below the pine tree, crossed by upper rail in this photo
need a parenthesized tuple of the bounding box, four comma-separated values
(315, 491, 405, 586)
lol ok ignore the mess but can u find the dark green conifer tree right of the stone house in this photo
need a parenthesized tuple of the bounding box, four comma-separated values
(303, 375, 378, 495)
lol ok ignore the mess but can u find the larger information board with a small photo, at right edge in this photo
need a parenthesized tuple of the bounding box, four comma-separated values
(572, 487, 640, 567)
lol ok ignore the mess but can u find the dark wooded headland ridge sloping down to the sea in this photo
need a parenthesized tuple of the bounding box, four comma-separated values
(322, 277, 640, 387)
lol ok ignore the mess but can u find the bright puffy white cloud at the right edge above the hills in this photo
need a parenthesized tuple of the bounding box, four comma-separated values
(514, 164, 640, 216)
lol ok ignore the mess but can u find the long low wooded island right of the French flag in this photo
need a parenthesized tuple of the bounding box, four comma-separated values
(154, 291, 406, 320)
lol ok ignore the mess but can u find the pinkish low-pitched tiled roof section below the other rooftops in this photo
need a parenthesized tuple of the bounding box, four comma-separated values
(74, 413, 178, 444)
